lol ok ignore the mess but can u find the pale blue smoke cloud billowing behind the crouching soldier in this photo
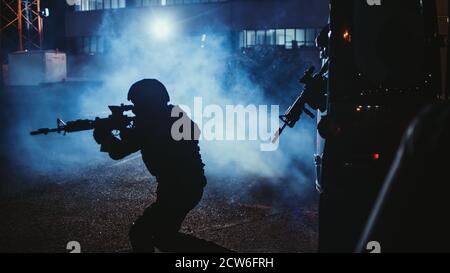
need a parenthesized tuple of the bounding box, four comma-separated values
(6, 10, 315, 202)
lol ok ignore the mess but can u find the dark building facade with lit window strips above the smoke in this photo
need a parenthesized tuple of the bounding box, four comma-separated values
(65, 0, 328, 55)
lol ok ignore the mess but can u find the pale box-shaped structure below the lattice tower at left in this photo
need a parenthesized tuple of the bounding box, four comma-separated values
(8, 50, 67, 85)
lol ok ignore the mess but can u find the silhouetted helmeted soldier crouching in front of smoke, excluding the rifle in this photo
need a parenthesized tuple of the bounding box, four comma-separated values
(94, 79, 230, 252)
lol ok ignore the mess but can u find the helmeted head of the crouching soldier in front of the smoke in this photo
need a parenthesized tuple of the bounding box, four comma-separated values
(128, 79, 170, 115)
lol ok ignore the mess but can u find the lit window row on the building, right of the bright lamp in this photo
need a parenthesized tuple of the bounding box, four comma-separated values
(239, 28, 320, 49)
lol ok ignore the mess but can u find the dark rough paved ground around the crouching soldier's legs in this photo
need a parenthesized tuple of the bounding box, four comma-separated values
(0, 154, 317, 252)
